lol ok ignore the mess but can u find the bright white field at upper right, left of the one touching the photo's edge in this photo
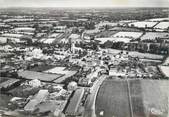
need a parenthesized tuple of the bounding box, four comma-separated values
(129, 21, 158, 28)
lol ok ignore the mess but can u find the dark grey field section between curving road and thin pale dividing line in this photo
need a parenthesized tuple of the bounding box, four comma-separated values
(96, 79, 131, 117)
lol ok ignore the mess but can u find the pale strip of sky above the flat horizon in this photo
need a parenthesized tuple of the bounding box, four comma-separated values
(0, 0, 169, 8)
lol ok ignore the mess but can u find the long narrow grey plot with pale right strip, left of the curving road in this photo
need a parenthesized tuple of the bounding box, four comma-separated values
(65, 88, 84, 116)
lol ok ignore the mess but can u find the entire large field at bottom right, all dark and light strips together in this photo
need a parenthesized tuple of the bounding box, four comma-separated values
(95, 79, 169, 117)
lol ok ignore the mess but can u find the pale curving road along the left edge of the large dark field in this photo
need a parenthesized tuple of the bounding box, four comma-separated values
(84, 75, 107, 117)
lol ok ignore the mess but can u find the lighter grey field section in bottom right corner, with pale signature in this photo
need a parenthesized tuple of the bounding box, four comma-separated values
(141, 80, 169, 117)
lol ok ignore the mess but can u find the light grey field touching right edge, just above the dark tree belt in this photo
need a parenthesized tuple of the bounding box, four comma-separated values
(141, 32, 169, 40)
